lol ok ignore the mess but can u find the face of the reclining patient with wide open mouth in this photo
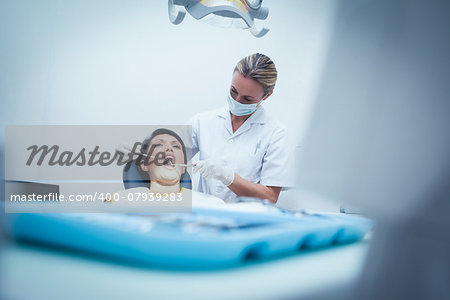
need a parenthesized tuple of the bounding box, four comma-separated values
(141, 134, 186, 185)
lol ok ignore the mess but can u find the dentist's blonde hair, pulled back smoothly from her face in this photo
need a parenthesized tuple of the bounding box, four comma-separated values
(234, 53, 278, 96)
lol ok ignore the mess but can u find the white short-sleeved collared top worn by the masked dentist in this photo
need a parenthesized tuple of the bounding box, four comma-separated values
(188, 106, 293, 202)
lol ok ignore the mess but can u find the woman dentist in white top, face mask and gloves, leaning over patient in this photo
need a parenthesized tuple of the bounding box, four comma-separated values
(189, 53, 292, 203)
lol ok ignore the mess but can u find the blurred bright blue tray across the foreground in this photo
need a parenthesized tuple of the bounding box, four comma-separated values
(6, 209, 372, 269)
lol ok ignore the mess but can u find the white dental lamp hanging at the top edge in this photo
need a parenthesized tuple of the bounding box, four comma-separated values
(168, 0, 269, 38)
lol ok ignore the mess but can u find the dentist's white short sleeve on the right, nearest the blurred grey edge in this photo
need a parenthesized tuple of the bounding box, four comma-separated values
(260, 127, 294, 187)
